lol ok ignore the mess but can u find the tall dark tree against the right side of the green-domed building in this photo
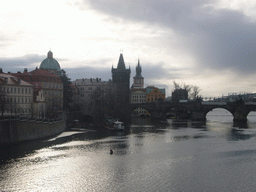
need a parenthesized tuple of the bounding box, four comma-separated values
(60, 69, 73, 110)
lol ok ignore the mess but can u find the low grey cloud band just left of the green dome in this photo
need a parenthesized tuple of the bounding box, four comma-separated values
(0, 54, 46, 72)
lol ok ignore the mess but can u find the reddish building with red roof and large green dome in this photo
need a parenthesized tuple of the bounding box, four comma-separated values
(12, 51, 63, 118)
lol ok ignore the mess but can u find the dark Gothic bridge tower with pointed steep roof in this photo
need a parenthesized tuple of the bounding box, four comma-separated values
(111, 54, 131, 119)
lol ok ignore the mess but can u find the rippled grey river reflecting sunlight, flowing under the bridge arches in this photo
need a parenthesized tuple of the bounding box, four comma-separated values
(0, 110, 256, 192)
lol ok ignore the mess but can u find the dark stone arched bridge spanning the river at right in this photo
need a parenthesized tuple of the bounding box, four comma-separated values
(131, 100, 256, 122)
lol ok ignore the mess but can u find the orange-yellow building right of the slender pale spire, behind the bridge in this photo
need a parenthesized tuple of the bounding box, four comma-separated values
(146, 86, 165, 103)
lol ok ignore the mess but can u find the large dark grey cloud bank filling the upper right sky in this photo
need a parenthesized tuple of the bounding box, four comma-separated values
(84, 0, 256, 74)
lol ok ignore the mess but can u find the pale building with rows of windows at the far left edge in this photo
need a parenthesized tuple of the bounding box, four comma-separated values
(0, 70, 33, 117)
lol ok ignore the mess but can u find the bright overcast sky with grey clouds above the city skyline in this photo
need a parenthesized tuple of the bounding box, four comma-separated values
(0, 0, 256, 97)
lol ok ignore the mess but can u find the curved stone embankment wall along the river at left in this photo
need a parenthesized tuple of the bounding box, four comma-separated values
(0, 120, 66, 145)
